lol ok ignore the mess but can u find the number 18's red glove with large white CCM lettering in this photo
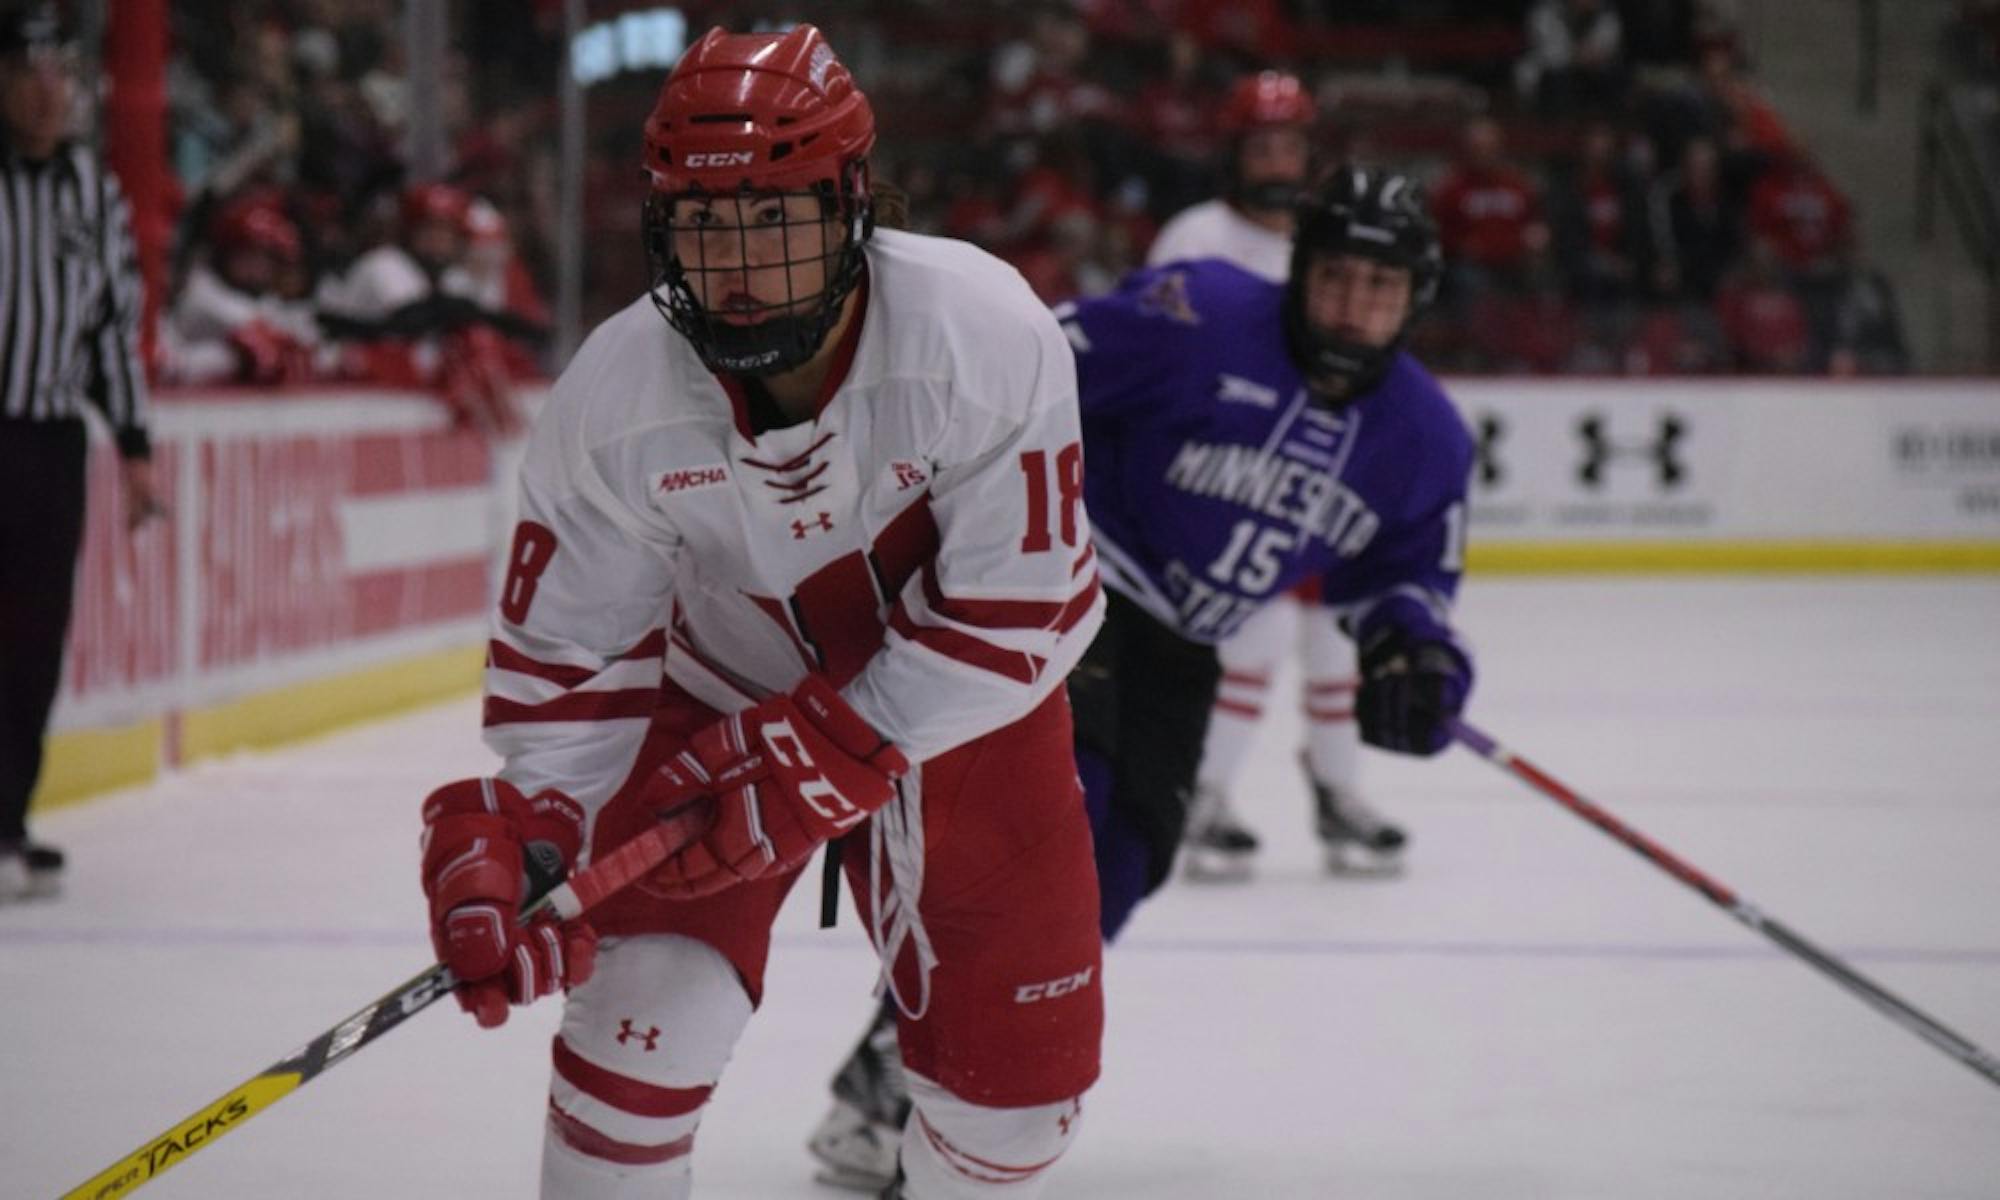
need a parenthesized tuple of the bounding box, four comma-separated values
(648, 676, 910, 898)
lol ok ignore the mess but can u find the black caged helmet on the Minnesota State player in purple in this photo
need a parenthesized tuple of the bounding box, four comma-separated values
(1284, 166, 1444, 396)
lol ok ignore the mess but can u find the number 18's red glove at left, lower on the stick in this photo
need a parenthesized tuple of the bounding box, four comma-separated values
(424, 778, 598, 1028)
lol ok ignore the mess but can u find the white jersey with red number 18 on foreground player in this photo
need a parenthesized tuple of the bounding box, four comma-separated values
(484, 230, 1104, 828)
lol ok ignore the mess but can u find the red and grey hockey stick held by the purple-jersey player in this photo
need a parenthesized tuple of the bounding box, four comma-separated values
(1450, 720, 2000, 1084)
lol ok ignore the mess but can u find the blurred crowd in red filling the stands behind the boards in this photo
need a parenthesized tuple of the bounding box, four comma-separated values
(162, 0, 1910, 398)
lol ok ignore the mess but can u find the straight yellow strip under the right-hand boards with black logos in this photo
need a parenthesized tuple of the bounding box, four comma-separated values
(1466, 542, 2000, 574)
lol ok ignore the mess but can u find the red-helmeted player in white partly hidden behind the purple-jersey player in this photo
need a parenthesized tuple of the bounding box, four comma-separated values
(1146, 70, 1404, 880)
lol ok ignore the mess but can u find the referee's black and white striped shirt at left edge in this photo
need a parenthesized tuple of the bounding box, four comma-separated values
(0, 142, 150, 458)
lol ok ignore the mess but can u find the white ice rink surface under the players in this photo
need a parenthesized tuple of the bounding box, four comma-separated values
(0, 576, 2000, 1200)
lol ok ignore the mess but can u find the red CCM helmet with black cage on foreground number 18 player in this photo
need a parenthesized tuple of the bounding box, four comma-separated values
(642, 24, 874, 374)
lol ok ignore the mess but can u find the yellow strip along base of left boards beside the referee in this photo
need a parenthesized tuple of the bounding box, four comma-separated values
(30, 646, 486, 812)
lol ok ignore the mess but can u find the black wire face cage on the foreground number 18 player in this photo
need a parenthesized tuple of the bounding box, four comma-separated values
(640, 162, 874, 376)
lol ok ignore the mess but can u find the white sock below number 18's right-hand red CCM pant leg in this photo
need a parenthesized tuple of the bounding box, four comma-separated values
(902, 1072, 1084, 1200)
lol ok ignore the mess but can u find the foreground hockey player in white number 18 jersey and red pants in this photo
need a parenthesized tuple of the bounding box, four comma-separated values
(424, 26, 1104, 1200)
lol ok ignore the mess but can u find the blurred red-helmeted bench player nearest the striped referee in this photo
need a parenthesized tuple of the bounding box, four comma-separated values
(160, 192, 320, 386)
